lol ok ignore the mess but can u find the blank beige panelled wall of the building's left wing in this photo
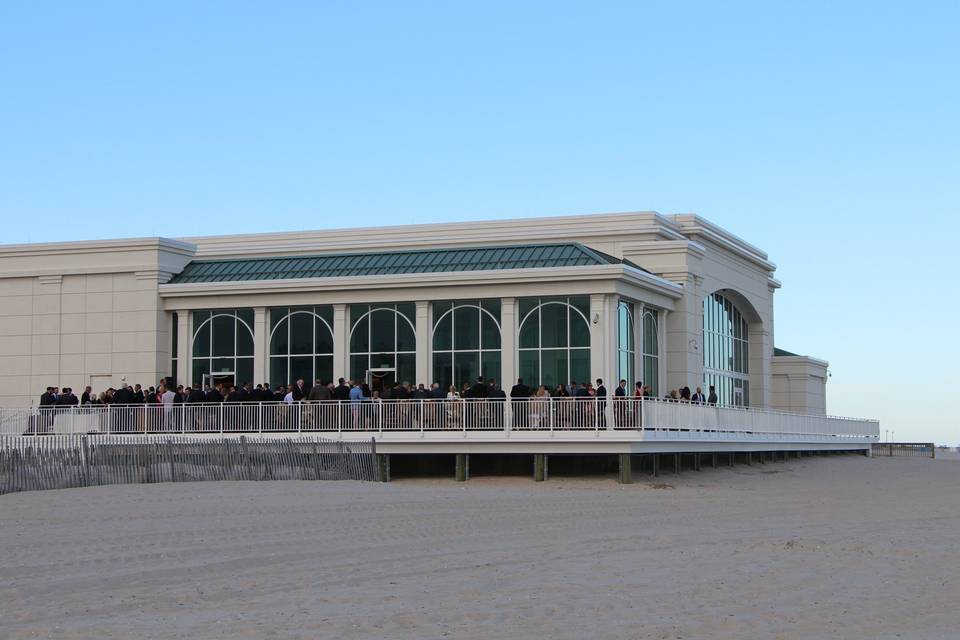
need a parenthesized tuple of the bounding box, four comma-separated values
(0, 239, 190, 406)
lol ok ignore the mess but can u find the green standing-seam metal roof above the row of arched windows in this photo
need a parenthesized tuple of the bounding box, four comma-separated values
(170, 242, 621, 284)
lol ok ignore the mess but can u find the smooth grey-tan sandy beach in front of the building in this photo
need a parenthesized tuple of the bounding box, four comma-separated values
(0, 456, 960, 639)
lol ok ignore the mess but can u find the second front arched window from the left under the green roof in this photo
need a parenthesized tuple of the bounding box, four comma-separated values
(270, 305, 333, 386)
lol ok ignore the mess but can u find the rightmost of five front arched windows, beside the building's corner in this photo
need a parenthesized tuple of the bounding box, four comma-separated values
(518, 296, 590, 390)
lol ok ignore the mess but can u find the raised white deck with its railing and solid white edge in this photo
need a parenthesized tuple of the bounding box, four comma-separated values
(0, 398, 880, 453)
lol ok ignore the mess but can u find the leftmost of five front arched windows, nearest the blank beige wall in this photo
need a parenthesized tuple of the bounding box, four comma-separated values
(191, 309, 254, 385)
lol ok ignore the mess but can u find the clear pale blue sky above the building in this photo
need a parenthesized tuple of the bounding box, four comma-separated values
(0, 0, 960, 443)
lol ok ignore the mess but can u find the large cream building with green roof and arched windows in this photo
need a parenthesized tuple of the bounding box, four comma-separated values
(0, 212, 827, 413)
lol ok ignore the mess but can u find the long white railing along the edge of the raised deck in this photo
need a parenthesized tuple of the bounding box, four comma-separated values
(0, 398, 880, 441)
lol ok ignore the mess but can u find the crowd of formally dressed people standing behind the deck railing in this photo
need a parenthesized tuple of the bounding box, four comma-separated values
(40, 378, 717, 407)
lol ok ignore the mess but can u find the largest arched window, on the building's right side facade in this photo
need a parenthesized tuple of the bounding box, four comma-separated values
(703, 293, 750, 407)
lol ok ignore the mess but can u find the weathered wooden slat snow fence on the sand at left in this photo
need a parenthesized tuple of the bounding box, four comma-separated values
(0, 435, 377, 495)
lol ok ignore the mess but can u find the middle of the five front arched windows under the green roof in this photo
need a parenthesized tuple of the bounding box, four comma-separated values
(350, 302, 417, 383)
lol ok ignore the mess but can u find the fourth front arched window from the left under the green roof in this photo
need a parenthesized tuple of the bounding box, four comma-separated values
(433, 300, 502, 390)
